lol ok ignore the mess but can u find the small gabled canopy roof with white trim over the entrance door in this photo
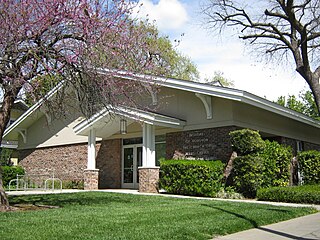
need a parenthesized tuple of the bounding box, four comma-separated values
(73, 106, 186, 138)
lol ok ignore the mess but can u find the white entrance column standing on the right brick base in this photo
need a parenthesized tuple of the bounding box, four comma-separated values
(142, 123, 156, 167)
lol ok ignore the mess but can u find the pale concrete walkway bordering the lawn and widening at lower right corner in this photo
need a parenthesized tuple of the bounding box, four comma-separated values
(7, 189, 320, 240)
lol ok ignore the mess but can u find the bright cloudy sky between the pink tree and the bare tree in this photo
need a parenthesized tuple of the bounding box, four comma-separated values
(133, 0, 307, 101)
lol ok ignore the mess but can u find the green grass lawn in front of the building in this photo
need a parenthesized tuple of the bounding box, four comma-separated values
(0, 192, 315, 240)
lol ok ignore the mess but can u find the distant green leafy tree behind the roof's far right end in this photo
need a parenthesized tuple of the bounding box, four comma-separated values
(276, 91, 320, 120)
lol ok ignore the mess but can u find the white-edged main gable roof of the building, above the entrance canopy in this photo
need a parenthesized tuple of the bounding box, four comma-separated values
(3, 69, 320, 140)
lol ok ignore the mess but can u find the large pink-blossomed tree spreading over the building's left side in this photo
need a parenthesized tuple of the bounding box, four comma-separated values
(0, 0, 175, 208)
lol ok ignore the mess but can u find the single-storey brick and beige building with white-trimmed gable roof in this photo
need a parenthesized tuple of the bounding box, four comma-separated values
(4, 72, 320, 192)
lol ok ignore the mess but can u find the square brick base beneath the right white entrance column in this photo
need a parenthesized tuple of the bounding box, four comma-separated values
(139, 167, 160, 193)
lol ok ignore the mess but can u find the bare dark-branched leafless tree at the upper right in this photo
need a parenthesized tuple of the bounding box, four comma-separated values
(203, 0, 320, 114)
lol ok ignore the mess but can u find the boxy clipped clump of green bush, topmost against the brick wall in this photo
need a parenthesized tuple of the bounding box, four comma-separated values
(229, 129, 265, 156)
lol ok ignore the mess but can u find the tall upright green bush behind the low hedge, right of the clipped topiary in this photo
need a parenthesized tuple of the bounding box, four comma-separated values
(259, 140, 293, 187)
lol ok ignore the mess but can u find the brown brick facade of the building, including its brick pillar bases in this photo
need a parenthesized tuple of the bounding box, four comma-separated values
(19, 126, 320, 192)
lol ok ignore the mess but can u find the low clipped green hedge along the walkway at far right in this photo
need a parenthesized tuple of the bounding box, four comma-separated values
(257, 185, 320, 204)
